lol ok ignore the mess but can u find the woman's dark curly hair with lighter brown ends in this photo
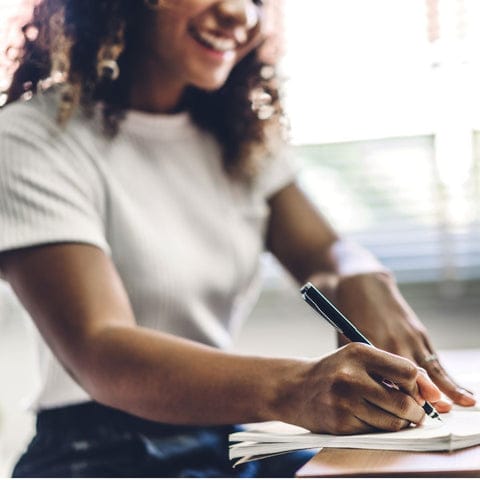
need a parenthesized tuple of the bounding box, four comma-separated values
(1, 0, 285, 176)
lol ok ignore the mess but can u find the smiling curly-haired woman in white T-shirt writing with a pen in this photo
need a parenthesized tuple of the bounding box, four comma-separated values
(0, 0, 474, 477)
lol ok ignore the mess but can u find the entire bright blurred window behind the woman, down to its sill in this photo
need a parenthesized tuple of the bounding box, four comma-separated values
(276, 0, 480, 282)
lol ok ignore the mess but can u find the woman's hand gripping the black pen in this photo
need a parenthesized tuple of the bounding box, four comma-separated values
(287, 343, 440, 434)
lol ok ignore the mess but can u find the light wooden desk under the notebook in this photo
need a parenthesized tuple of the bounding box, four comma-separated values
(297, 350, 480, 478)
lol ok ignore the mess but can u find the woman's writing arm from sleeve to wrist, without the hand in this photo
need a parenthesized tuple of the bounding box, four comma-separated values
(1, 244, 288, 424)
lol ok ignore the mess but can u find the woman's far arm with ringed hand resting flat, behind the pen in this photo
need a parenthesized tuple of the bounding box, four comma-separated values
(267, 184, 475, 411)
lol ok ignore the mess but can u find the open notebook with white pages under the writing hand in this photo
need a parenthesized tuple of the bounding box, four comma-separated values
(229, 407, 480, 464)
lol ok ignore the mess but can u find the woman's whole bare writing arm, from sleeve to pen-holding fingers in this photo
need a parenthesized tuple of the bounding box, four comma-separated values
(0, 244, 437, 433)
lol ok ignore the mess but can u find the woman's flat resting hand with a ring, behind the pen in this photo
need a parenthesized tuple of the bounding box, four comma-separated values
(335, 273, 475, 413)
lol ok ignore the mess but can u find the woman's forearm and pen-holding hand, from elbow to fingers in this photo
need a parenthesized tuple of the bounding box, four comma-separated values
(73, 327, 448, 433)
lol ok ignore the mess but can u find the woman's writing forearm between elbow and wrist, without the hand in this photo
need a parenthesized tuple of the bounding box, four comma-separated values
(72, 327, 308, 425)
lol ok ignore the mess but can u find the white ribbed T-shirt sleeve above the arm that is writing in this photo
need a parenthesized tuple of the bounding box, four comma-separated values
(0, 110, 109, 253)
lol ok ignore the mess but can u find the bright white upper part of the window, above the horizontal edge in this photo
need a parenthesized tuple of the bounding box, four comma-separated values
(284, 0, 480, 144)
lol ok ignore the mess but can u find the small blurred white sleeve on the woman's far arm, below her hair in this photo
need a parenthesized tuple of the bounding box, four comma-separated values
(256, 145, 299, 198)
